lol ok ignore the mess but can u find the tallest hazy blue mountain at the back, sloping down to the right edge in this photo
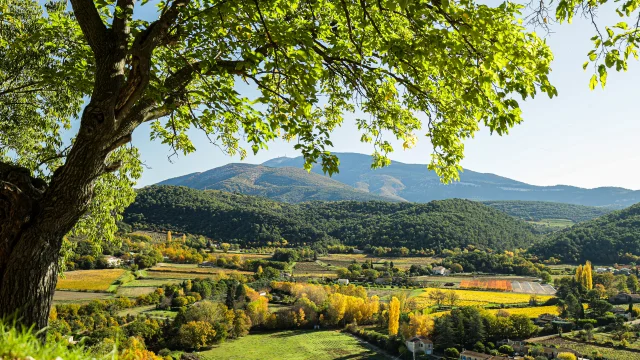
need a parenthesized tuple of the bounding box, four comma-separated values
(263, 153, 640, 209)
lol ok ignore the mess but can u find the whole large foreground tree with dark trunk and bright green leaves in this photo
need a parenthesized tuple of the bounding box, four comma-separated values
(0, 0, 557, 328)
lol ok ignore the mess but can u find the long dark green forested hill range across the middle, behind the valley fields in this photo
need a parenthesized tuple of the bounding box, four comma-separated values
(125, 186, 538, 251)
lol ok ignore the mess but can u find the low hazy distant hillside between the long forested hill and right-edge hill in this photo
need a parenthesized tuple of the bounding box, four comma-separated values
(482, 200, 614, 223)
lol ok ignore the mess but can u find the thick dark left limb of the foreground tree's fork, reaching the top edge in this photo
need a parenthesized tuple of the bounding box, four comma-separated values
(71, 0, 108, 55)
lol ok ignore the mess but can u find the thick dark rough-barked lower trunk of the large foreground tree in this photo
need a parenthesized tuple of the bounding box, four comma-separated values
(0, 104, 126, 329)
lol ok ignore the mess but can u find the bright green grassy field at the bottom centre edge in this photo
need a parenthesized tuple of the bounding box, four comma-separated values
(200, 331, 387, 360)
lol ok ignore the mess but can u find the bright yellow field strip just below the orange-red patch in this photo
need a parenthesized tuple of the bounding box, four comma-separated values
(416, 289, 553, 307)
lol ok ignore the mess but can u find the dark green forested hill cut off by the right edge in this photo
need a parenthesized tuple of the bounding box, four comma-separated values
(531, 204, 640, 264)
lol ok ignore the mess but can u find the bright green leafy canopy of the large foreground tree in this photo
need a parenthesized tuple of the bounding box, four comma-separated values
(0, 0, 556, 246)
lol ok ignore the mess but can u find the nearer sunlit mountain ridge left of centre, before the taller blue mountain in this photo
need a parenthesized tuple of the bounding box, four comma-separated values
(158, 164, 397, 203)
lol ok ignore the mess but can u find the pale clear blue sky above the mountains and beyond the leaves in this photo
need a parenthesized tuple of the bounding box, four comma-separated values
(127, 2, 640, 190)
